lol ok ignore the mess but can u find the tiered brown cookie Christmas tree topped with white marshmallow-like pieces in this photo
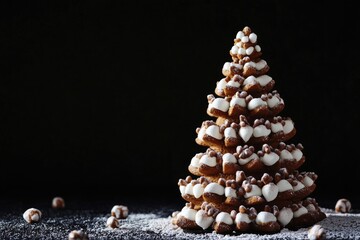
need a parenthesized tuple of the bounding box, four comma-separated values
(172, 27, 326, 233)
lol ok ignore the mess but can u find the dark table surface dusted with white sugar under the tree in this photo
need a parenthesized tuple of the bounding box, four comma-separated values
(0, 196, 360, 240)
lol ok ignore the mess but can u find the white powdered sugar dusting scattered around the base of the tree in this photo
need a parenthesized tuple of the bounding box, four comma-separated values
(0, 207, 360, 240)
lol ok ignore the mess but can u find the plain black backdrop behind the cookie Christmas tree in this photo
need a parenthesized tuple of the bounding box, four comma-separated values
(0, 0, 360, 208)
